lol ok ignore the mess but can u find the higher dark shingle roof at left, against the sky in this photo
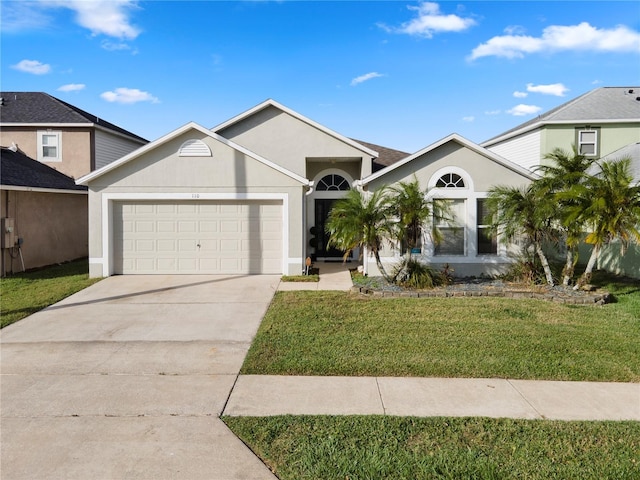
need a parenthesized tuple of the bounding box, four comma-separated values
(0, 92, 147, 143)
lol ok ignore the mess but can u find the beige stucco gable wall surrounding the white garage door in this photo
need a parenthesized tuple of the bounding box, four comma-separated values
(89, 131, 304, 276)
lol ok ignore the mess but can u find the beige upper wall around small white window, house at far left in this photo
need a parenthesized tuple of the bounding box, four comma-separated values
(0, 127, 92, 178)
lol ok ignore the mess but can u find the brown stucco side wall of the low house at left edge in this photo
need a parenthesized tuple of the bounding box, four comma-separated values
(0, 190, 88, 273)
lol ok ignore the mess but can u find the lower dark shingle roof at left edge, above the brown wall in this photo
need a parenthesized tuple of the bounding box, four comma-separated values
(0, 147, 87, 191)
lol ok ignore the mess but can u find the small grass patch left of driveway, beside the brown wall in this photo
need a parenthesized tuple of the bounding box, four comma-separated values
(0, 259, 99, 328)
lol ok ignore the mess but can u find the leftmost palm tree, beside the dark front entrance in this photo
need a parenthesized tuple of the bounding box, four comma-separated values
(326, 187, 397, 282)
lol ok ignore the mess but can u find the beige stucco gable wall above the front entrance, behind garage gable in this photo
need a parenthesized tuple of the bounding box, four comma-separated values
(218, 107, 371, 178)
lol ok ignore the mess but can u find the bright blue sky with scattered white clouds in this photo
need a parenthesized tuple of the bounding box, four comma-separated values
(0, 0, 640, 152)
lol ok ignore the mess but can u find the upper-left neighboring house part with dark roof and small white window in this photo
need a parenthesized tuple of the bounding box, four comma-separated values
(0, 92, 147, 178)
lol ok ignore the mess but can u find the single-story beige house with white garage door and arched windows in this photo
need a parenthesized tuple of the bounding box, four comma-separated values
(78, 100, 534, 277)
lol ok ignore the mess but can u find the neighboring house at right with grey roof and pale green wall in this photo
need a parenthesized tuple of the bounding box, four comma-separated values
(481, 87, 640, 171)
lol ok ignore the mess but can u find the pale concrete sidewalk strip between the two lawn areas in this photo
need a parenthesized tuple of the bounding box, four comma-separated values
(223, 375, 640, 420)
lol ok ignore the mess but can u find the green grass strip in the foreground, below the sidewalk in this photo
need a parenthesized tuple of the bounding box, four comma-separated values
(223, 416, 640, 480)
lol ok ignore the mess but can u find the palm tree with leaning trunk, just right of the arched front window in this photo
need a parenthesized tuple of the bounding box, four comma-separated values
(487, 183, 553, 286)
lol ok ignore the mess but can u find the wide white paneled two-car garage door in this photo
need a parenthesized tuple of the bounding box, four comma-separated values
(113, 200, 282, 274)
